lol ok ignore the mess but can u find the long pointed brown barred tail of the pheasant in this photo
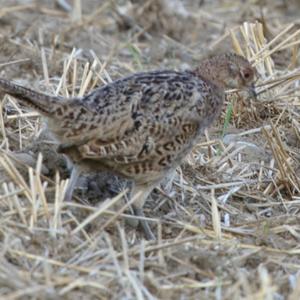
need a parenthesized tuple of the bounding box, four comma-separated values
(0, 78, 62, 116)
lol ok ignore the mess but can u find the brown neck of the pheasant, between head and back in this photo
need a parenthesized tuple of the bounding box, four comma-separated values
(193, 59, 225, 91)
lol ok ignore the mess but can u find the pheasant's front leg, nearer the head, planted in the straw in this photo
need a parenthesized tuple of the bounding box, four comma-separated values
(131, 185, 156, 240)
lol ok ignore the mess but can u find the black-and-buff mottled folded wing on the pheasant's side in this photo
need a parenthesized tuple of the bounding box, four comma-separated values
(59, 71, 206, 163)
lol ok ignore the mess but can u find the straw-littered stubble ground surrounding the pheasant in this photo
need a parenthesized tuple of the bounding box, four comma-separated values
(0, 0, 300, 300)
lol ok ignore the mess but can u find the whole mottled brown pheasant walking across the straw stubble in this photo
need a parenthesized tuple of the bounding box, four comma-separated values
(0, 53, 255, 238)
